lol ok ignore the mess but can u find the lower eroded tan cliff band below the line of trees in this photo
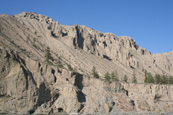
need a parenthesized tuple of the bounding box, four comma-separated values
(0, 49, 173, 114)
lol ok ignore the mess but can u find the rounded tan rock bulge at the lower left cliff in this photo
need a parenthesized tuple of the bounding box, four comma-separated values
(0, 49, 38, 113)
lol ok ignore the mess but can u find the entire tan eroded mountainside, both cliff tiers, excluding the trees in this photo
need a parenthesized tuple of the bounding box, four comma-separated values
(0, 12, 173, 114)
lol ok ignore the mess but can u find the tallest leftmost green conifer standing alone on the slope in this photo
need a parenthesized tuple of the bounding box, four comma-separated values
(45, 47, 53, 65)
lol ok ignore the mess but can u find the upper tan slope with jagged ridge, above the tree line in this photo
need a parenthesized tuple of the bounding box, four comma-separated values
(0, 12, 173, 83)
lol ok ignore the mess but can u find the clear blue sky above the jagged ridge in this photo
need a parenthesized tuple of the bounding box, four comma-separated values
(0, 0, 173, 53)
